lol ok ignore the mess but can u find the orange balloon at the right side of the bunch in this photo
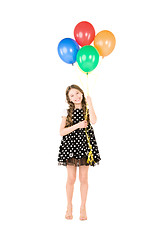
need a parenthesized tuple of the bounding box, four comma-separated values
(94, 30, 116, 57)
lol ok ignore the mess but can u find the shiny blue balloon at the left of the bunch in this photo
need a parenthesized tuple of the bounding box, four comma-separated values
(58, 38, 80, 64)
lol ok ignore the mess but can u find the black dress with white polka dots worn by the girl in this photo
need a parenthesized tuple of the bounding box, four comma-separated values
(58, 108, 101, 166)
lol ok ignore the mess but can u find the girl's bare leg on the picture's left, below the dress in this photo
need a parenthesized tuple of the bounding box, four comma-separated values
(66, 165, 76, 218)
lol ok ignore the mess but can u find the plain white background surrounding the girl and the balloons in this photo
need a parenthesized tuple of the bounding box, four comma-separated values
(0, 0, 164, 240)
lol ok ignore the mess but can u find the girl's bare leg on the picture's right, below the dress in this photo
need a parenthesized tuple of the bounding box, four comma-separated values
(79, 166, 89, 220)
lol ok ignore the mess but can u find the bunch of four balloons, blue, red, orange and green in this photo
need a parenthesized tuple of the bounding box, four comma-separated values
(58, 21, 116, 74)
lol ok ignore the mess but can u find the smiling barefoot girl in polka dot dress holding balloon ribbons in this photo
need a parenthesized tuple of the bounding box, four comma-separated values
(58, 85, 101, 220)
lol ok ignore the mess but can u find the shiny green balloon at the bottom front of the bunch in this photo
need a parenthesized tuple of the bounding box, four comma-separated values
(76, 45, 99, 73)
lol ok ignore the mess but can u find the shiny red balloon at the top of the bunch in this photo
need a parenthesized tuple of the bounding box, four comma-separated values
(74, 21, 95, 47)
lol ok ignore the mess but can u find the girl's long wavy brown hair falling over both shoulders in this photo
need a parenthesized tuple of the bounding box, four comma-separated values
(66, 84, 90, 127)
